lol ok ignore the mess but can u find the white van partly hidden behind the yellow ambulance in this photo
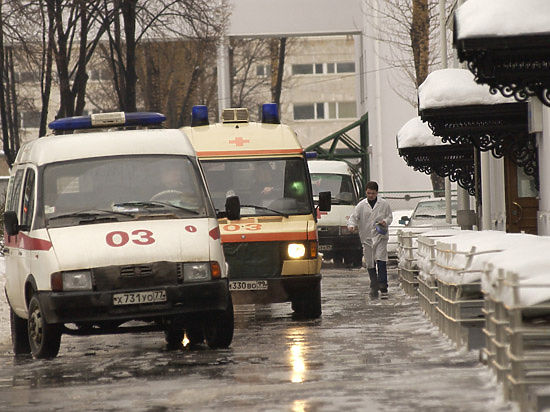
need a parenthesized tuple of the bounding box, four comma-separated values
(308, 160, 363, 267)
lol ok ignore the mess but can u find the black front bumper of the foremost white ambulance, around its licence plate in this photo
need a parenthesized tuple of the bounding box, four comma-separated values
(38, 279, 229, 323)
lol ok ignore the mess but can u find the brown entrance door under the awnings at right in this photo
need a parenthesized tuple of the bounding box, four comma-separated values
(504, 157, 539, 235)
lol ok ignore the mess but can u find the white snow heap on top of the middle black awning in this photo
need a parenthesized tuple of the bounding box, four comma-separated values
(418, 69, 516, 110)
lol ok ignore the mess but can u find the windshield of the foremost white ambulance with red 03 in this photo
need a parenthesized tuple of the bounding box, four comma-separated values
(42, 155, 213, 226)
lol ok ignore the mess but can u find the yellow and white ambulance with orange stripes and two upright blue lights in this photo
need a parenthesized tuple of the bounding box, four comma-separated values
(182, 104, 330, 318)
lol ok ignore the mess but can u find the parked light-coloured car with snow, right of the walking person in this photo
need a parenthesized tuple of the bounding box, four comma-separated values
(399, 198, 457, 227)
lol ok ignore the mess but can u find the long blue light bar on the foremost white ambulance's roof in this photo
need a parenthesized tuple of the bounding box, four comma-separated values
(48, 112, 166, 131)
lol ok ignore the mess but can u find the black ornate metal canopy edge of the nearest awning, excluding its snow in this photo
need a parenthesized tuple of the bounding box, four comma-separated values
(454, 34, 550, 107)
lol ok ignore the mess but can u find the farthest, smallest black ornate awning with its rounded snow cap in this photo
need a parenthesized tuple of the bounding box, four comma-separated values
(397, 116, 475, 195)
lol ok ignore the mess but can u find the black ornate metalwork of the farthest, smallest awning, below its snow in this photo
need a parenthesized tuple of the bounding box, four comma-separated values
(399, 144, 479, 196)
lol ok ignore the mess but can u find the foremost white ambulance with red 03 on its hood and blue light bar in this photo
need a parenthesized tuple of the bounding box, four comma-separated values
(4, 113, 238, 358)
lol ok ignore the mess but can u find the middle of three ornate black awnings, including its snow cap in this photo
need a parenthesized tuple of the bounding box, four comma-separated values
(418, 69, 538, 186)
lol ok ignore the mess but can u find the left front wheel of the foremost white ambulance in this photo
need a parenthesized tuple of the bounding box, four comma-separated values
(27, 295, 61, 359)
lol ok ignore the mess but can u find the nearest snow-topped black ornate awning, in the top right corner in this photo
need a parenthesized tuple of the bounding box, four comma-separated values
(453, 0, 550, 106)
